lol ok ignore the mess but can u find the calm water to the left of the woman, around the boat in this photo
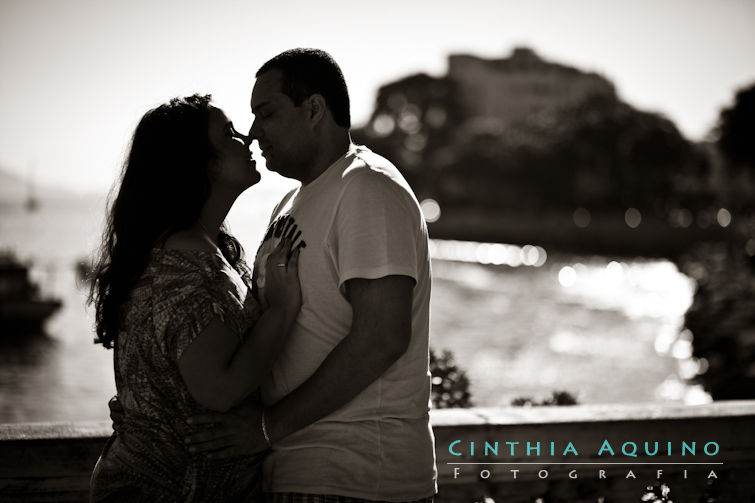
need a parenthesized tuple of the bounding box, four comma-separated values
(0, 195, 115, 422)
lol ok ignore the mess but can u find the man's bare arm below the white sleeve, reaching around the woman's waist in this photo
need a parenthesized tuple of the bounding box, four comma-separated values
(265, 276, 414, 443)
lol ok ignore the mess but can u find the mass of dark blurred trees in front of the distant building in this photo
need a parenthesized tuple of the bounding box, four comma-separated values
(353, 58, 709, 216)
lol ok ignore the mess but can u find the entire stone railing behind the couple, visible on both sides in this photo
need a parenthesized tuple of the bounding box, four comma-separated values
(0, 401, 755, 503)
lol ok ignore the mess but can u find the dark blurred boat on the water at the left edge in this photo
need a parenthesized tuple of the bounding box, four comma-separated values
(0, 253, 62, 335)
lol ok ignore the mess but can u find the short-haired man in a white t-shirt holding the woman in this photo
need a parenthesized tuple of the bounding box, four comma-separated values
(189, 49, 437, 502)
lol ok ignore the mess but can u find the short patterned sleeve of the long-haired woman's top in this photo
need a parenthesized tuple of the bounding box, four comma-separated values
(166, 285, 226, 361)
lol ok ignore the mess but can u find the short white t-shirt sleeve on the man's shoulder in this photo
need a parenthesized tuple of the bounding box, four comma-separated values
(328, 171, 422, 291)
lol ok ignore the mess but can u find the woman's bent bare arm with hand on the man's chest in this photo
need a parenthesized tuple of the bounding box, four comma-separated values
(178, 240, 301, 412)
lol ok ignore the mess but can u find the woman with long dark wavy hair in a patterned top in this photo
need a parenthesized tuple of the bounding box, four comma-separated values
(90, 95, 301, 502)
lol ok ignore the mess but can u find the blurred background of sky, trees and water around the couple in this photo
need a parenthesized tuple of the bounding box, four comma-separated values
(0, 0, 755, 423)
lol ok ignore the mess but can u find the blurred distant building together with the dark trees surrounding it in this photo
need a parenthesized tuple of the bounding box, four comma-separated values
(353, 48, 707, 220)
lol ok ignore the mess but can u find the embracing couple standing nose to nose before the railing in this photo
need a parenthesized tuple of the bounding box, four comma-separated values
(91, 49, 437, 503)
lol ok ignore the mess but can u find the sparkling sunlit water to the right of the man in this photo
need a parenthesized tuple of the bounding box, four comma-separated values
(432, 256, 708, 406)
